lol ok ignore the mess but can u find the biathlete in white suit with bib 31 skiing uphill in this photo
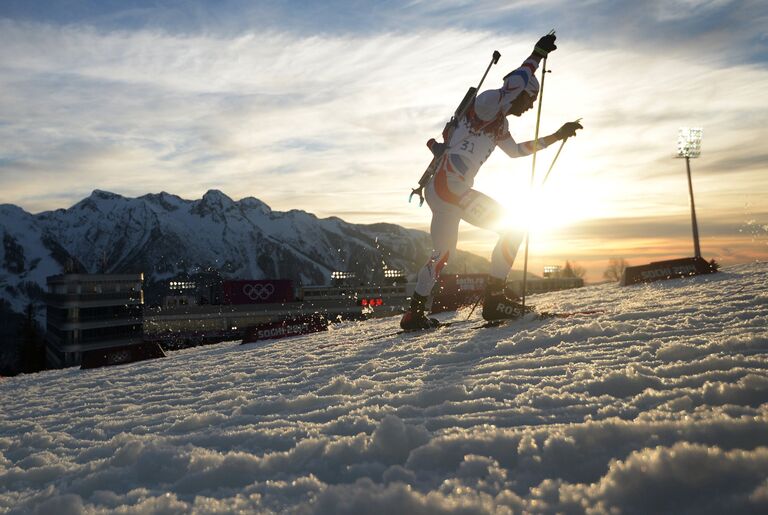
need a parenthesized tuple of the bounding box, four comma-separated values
(400, 34, 583, 330)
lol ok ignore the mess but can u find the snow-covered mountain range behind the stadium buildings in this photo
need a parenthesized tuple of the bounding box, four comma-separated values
(0, 190, 487, 312)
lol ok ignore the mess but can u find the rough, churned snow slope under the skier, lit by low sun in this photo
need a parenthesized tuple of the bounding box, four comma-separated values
(0, 263, 768, 515)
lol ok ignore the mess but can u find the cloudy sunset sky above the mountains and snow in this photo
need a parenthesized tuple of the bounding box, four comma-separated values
(0, 0, 768, 280)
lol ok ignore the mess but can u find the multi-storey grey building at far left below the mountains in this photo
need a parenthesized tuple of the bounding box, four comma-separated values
(46, 274, 144, 368)
